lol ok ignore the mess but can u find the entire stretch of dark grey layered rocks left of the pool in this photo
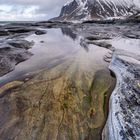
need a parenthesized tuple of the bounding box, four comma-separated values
(0, 24, 46, 76)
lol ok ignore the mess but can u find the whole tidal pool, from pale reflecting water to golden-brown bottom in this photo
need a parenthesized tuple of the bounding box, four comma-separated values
(0, 26, 115, 140)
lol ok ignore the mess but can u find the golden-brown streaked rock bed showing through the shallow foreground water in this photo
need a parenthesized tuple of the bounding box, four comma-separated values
(0, 60, 114, 140)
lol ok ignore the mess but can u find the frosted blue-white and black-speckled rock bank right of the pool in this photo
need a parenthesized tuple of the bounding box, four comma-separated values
(103, 54, 140, 140)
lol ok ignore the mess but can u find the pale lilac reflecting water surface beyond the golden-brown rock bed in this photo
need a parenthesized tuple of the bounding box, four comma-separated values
(0, 28, 107, 86)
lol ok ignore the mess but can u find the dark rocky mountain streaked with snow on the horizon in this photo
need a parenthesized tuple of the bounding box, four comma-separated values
(55, 0, 136, 20)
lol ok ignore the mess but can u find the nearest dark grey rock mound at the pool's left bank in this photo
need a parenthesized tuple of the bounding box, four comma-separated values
(0, 40, 32, 76)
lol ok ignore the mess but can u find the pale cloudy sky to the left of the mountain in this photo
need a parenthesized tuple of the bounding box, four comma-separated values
(0, 0, 69, 21)
